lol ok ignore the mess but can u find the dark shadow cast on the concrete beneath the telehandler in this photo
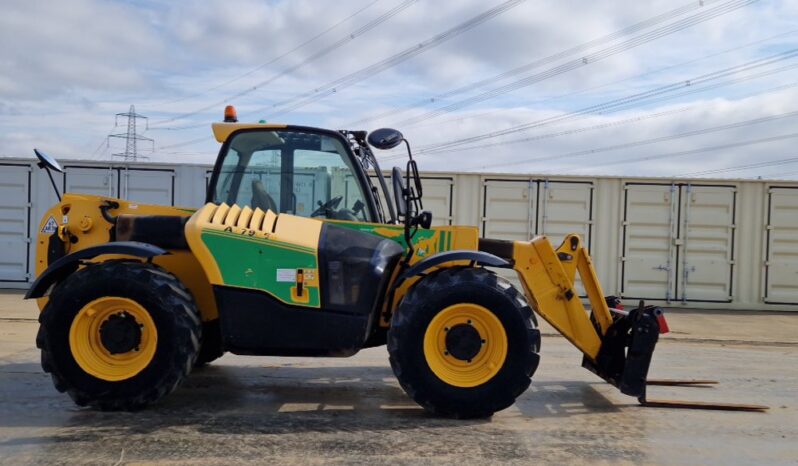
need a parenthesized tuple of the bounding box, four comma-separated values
(0, 363, 619, 447)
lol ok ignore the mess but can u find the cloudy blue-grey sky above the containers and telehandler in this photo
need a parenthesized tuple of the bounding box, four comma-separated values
(0, 0, 798, 179)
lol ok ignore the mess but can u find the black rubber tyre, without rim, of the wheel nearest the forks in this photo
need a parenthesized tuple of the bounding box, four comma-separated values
(388, 268, 540, 419)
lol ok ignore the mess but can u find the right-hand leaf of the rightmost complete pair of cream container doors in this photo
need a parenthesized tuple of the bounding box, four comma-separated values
(677, 185, 736, 302)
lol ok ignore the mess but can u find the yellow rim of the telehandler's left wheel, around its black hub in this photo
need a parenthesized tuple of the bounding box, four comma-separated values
(69, 296, 158, 382)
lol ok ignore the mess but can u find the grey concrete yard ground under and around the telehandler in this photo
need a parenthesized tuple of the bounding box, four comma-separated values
(0, 293, 798, 465)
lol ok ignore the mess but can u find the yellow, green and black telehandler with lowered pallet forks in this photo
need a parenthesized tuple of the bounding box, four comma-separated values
(26, 107, 762, 418)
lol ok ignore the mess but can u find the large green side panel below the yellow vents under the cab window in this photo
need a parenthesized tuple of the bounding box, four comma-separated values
(201, 230, 321, 307)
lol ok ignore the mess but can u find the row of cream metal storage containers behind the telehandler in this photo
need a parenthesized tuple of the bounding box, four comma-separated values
(0, 159, 798, 310)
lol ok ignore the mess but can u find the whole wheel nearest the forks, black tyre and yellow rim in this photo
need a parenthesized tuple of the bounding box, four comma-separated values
(388, 268, 540, 418)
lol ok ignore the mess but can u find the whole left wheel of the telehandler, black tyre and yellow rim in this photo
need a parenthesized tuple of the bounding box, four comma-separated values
(36, 261, 202, 410)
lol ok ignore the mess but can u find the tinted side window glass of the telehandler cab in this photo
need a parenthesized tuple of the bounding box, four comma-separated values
(213, 129, 373, 221)
